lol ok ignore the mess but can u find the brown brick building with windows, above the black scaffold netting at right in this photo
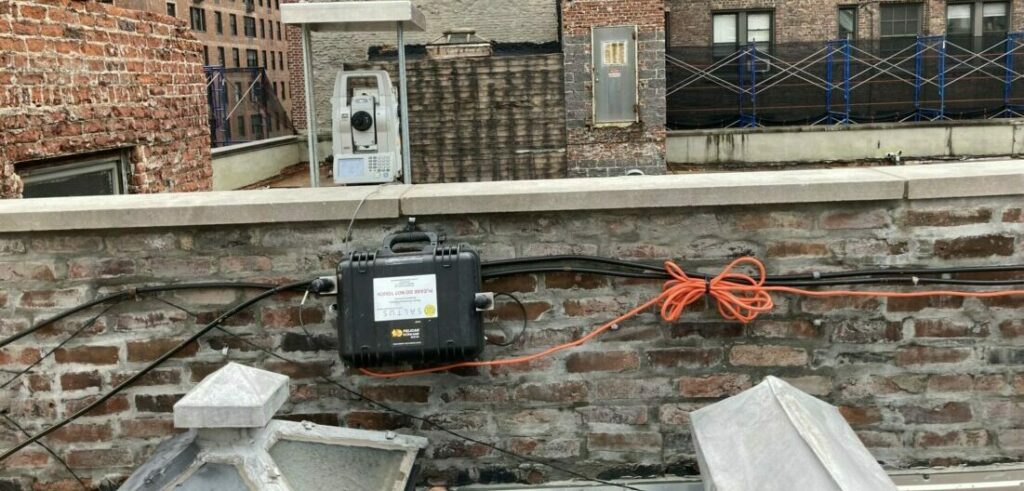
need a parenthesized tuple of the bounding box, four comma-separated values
(667, 0, 1024, 48)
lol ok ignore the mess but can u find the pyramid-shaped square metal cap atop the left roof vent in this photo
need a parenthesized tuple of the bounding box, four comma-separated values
(174, 362, 288, 427)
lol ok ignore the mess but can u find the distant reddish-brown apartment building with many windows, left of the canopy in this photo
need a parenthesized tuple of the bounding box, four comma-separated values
(114, 0, 292, 141)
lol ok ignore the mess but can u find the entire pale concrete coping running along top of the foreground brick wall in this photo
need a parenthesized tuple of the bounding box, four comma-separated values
(0, 160, 1024, 233)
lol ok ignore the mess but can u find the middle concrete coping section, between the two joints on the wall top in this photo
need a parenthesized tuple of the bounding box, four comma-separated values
(401, 168, 904, 215)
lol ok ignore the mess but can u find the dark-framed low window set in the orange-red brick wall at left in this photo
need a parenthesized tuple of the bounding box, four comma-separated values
(17, 152, 129, 198)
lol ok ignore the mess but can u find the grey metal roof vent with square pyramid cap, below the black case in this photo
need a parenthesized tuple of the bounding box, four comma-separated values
(121, 363, 427, 491)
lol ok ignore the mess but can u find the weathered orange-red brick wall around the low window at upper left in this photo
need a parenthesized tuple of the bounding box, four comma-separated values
(0, 0, 211, 197)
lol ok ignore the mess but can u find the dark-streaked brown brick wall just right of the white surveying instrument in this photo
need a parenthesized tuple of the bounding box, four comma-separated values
(346, 54, 565, 183)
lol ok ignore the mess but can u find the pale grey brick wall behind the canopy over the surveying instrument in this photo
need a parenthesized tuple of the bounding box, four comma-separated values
(286, 0, 558, 130)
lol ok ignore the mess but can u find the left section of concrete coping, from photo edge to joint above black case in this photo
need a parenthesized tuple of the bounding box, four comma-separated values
(0, 186, 407, 232)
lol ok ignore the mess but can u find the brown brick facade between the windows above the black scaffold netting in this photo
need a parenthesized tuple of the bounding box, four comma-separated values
(667, 0, 1024, 47)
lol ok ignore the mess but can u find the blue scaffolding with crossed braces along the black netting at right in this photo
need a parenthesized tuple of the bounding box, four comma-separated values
(666, 33, 1024, 128)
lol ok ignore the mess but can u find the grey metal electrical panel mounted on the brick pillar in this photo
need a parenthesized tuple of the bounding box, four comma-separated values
(591, 26, 637, 124)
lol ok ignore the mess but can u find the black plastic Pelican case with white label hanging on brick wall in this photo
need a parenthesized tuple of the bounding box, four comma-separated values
(338, 232, 483, 367)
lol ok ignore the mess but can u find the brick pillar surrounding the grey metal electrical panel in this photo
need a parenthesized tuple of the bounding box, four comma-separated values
(560, 0, 666, 176)
